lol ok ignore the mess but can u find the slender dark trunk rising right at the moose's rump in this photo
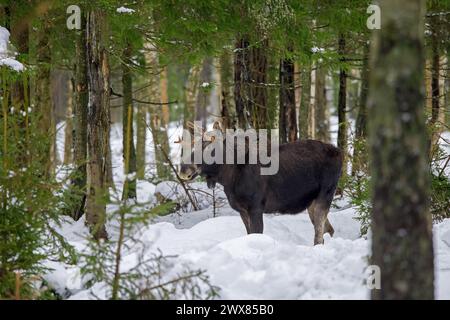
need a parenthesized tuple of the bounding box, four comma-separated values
(337, 34, 348, 175)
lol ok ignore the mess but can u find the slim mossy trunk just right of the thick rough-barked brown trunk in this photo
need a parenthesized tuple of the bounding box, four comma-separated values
(122, 44, 136, 200)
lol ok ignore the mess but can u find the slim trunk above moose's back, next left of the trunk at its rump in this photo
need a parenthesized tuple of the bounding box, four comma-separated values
(314, 65, 330, 142)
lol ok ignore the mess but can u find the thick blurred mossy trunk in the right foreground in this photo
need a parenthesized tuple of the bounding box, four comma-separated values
(369, 0, 434, 300)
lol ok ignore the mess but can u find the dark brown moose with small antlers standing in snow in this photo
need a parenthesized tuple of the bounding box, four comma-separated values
(178, 122, 343, 245)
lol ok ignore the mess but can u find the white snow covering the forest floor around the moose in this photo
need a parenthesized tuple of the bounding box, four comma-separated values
(45, 121, 450, 299)
